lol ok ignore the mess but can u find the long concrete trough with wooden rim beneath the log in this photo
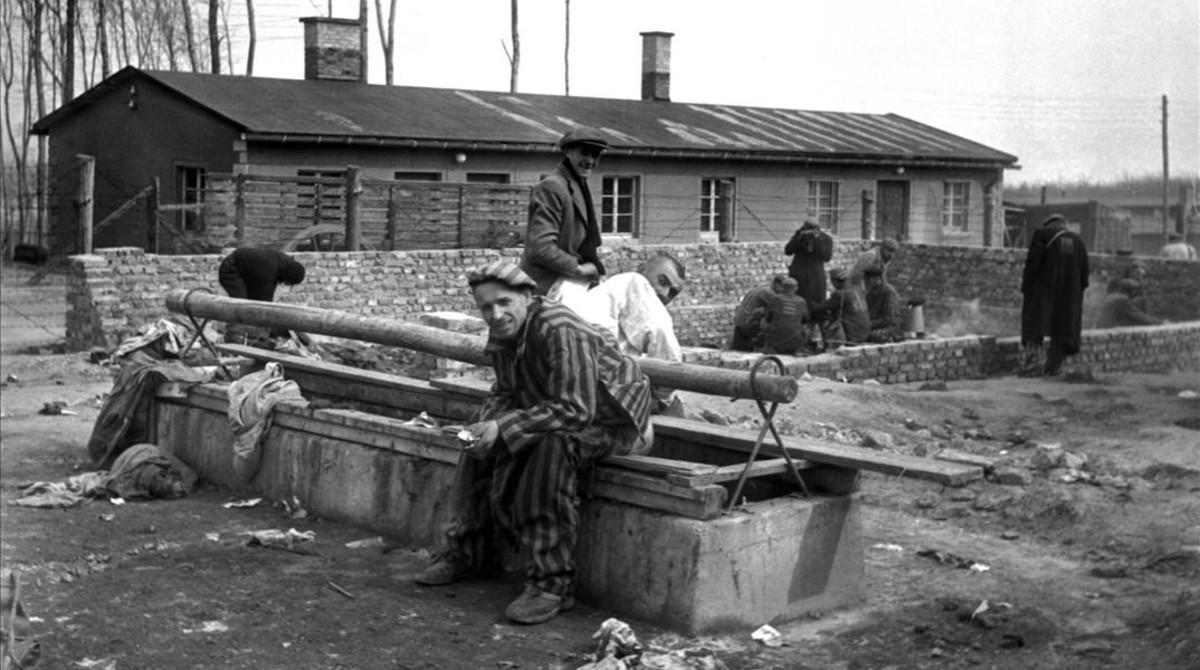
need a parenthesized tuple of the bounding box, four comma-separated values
(155, 364, 864, 635)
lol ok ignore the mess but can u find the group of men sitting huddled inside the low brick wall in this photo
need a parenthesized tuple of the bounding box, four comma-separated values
(728, 265, 906, 355)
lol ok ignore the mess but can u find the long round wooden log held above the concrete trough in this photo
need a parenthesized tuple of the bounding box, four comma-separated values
(167, 288, 799, 402)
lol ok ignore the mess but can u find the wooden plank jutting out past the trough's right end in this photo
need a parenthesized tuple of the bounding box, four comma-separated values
(654, 417, 983, 486)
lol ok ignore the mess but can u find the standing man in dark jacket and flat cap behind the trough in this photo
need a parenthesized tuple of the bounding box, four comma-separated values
(521, 126, 608, 299)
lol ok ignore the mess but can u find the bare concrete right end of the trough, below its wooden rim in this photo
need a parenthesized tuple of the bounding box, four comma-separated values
(576, 496, 865, 635)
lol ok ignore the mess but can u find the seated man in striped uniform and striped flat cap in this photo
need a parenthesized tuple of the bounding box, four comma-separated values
(416, 261, 654, 623)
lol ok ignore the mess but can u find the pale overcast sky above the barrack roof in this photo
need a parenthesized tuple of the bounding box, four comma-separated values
(229, 0, 1200, 184)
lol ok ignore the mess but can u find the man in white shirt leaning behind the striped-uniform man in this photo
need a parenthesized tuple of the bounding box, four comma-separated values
(563, 253, 686, 415)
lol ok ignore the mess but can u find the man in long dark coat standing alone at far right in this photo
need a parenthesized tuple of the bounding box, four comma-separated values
(1021, 214, 1088, 375)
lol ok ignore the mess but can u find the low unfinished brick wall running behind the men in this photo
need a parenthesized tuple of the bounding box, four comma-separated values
(67, 241, 1200, 381)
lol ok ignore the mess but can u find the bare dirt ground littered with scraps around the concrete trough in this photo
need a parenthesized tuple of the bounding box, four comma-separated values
(0, 353, 1200, 670)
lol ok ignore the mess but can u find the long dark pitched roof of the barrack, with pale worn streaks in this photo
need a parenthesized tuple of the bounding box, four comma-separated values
(35, 67, 1016, 167)
